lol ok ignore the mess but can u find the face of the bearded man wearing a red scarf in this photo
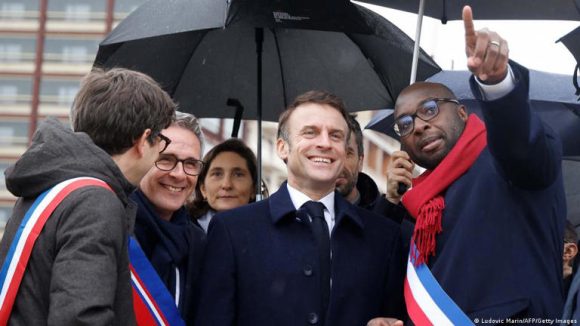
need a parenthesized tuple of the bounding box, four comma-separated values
(394, 83, 467, 170)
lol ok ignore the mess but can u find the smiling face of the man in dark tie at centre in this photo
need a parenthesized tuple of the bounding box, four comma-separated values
(277, 103, 348, 199)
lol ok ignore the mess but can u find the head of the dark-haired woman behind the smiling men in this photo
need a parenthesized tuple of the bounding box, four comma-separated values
(190, 138, 258, 232)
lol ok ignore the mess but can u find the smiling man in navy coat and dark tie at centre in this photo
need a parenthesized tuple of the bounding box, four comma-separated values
(196, 91, 405, 326)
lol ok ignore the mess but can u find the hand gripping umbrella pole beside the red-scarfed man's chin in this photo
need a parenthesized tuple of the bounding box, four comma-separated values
(386, 151, 415, 205)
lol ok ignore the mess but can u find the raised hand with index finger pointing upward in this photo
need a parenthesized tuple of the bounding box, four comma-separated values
(463, 6, 509, 84)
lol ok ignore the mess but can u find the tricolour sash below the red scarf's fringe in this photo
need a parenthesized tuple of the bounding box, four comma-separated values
(405, 243, 473, 326)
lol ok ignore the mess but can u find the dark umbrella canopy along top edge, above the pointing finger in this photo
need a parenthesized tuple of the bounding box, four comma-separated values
(360, 0, 580, 24)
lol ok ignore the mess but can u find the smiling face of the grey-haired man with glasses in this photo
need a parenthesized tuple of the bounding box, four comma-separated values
(139, 124, 201, 220)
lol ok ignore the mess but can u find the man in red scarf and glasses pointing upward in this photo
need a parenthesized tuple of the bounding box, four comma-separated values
(375, 7, 566, 325)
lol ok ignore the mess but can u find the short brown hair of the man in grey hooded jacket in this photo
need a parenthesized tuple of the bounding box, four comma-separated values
(70, 68, 177, 155)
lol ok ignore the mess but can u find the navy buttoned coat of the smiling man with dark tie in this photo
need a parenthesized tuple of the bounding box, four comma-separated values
(196, 184, 404, 326)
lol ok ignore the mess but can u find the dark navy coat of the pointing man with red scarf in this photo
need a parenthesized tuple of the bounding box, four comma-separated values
(394, 64, 566, 323)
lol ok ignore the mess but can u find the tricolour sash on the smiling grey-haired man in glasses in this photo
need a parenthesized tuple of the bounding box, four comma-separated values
(129, 237, 185, 326)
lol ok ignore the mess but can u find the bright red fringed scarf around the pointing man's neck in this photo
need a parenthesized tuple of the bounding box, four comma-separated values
(403, 114, 487, 266)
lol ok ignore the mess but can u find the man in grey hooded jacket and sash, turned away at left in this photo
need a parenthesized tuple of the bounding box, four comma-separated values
(0, 69, 176, 325)
